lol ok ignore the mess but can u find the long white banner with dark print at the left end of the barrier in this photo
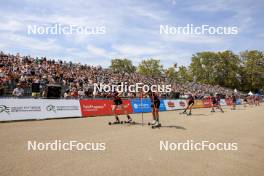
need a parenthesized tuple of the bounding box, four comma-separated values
(0, 99, 81, 121)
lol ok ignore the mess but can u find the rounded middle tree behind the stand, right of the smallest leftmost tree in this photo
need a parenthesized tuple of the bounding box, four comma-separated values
(138, 59, 163, 77)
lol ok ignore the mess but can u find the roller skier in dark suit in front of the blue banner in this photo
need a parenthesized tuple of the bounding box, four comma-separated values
(148, 90, 160, 126)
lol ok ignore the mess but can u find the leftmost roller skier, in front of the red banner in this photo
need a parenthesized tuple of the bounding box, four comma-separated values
(109, 90, 132, 123)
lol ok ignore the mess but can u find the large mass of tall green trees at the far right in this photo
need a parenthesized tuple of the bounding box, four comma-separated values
(190, 51, 264, 91)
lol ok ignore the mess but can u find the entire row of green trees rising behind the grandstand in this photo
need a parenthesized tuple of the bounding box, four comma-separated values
(110, 50, 264, 92)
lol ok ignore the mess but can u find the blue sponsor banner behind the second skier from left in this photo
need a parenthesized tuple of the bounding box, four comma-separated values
(131, 98, 166, 113)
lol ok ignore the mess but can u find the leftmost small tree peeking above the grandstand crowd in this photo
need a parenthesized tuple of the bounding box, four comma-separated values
(110, 59, 136, 73)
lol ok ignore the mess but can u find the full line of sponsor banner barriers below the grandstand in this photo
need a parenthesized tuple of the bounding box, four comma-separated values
(0, 98, 241, 121)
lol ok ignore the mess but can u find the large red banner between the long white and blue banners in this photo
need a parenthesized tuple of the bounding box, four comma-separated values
(80, 100, 133, 117)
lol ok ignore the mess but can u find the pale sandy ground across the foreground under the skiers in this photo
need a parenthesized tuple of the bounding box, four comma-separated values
(0, 105, 264, 176)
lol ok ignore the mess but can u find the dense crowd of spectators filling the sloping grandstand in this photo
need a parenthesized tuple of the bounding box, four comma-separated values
(0, 51, 238, 98)
